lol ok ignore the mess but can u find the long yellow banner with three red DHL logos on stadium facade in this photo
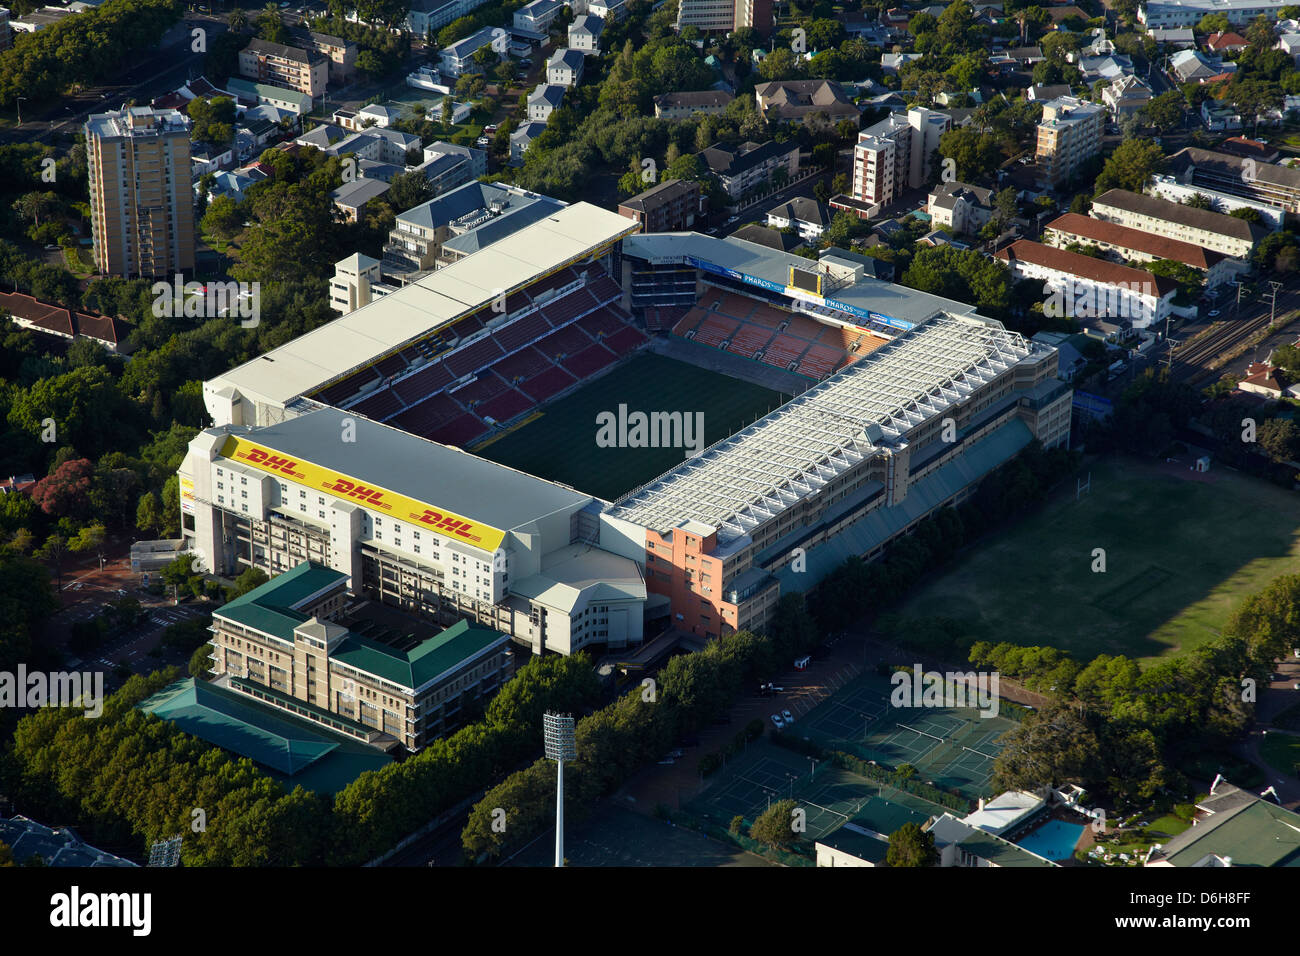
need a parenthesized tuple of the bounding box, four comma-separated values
(221, 436, 506, 551)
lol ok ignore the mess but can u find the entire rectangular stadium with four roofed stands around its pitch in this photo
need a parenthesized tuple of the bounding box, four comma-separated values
(179, 203, 1071, 654)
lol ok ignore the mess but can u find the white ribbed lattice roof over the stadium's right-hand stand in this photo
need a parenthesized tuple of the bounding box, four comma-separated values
(608, 315, 1032, 544)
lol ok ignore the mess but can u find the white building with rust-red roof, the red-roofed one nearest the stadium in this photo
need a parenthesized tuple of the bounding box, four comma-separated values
(993, 239, 1178, 329)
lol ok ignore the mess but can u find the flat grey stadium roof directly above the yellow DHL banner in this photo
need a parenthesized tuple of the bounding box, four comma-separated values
(220, 405, 592, 530)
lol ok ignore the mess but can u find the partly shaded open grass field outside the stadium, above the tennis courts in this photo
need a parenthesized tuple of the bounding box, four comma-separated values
(891, 458, 1300, 661)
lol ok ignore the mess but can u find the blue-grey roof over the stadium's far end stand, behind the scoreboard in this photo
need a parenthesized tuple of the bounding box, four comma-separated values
(623, 233, 976, 325)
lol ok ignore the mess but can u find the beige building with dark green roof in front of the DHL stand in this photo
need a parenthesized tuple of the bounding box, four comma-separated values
(211, 562, 514, 750)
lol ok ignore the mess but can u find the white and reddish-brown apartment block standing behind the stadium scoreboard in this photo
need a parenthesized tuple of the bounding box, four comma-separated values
(852, 107, 953, 206)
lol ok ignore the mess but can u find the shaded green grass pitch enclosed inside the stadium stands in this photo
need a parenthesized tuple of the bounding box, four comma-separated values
(473, 352, 785, 501)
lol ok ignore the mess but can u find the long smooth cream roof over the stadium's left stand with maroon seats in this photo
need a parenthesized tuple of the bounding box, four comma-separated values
(208, 203, 638, 406)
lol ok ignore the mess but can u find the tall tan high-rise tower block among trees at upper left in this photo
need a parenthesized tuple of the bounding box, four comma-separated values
(85, 107, 194, 278)
